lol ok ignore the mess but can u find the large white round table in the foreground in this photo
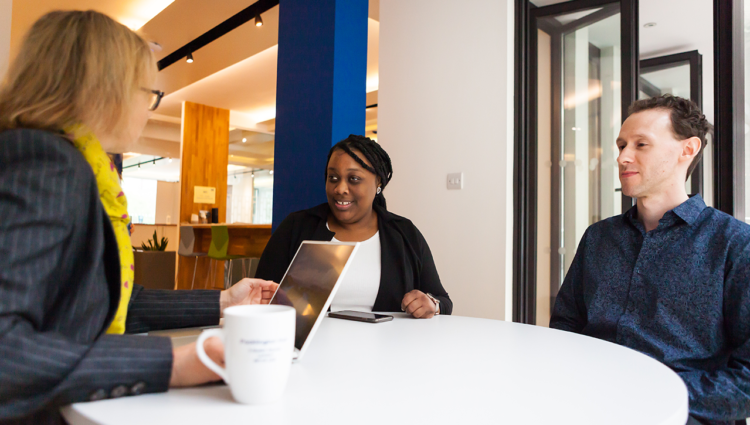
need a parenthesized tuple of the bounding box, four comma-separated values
(63, 314, 688, 425)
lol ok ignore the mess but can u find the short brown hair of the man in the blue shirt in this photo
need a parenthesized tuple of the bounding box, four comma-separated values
(628, 94, 713, 180)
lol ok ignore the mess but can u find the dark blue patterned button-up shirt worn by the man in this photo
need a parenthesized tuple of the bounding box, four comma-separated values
(550, 195, 750, 424)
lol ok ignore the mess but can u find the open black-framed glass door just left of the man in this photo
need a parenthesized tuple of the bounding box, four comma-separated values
(527, 1, 638, 326)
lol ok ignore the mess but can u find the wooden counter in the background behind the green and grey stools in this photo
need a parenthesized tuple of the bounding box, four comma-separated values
(177, 223, 271, 289)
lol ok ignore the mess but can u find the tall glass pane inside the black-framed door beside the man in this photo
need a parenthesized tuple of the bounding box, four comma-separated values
(558, 14, 622, 282)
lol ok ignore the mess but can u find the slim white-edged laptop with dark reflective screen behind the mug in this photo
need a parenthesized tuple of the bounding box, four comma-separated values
(271, 241, 359, 361)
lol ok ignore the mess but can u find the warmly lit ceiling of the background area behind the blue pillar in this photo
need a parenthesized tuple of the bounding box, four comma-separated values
(126, 0, 380, 174)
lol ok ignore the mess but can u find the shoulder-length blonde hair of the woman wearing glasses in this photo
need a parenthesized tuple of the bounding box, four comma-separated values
(0, 10, 156, 138)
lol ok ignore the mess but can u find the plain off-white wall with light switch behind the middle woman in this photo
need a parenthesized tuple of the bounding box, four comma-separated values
(378, 0, 514, 320)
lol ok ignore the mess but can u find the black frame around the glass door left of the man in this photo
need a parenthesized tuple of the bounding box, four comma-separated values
(513, 0, 639, 325)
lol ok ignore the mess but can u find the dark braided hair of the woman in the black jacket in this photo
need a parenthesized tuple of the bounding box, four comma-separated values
(325, 134, 393, 209)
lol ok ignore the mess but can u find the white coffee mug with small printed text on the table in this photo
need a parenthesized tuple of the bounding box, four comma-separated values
(196, 305, 296, 404)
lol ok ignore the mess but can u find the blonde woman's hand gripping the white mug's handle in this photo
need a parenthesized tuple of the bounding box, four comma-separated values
(169, 337, 224, 387)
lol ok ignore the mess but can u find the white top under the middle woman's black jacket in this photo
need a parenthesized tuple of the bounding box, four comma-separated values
(331, 231, 380, 311)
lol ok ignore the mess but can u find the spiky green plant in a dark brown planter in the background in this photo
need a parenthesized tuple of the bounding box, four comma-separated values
(133, 230, 176, 289)
